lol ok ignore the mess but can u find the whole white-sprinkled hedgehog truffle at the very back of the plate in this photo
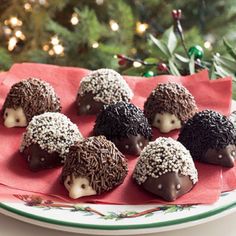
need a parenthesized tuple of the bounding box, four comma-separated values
(76, 69, 133, 115)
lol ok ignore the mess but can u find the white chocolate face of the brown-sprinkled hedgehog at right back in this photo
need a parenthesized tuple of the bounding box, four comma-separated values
(152, 112, 181, 133)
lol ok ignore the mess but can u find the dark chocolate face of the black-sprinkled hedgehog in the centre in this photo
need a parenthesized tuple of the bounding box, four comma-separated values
(112, 134, 149, 156)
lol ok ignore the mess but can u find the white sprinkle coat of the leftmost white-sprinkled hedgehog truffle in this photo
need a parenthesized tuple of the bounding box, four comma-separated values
(20, 112, 83, 162)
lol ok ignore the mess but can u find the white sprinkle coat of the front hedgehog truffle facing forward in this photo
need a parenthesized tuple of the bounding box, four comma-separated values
(133, 137, 198, 185)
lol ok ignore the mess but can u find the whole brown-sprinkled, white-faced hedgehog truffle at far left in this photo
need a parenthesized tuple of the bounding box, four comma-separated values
(2, 78, 61, 128)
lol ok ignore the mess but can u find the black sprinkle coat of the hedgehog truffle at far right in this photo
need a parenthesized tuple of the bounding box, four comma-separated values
(178, 110, 236, 160)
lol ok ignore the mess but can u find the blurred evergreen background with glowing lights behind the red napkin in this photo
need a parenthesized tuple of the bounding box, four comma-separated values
(0, 0, 236, 89)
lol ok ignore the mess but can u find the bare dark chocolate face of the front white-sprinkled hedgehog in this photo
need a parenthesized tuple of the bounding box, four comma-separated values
(142, 172, 193, 202)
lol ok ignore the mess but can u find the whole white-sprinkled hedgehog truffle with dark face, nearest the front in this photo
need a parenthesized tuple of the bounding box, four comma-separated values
(133, 138, 198, 201)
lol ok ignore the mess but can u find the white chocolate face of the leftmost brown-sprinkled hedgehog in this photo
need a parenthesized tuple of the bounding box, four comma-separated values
(3, 107, 27, 128)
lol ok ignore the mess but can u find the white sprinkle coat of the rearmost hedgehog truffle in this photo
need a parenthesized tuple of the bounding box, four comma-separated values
(78, 68, 133, 104)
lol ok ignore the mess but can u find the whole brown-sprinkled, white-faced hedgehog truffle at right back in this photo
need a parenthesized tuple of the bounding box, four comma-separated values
(144, 83, 197, 133)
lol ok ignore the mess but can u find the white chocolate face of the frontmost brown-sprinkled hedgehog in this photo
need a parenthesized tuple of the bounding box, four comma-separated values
(64, 174, 97, 199)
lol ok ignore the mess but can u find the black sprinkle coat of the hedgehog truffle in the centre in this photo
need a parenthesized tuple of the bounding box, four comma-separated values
(94, 102, 152, 140)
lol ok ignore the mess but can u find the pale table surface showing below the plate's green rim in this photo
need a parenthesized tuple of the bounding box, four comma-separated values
(0, 212, 236, 236)
